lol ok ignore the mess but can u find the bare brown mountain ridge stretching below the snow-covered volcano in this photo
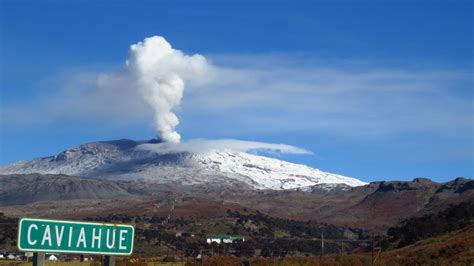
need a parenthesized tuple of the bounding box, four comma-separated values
(0, 174, 474, 230)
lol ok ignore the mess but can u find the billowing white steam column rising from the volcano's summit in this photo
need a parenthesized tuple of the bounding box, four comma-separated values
(127, 36, 211, 143)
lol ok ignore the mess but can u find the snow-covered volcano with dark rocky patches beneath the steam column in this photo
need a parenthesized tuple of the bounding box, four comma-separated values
(0, 139, 366, 190)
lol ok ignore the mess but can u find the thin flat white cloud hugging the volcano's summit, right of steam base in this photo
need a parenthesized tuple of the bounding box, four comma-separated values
(137, 139, 312, 154)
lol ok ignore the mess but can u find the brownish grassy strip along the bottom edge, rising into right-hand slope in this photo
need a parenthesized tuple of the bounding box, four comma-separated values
(0, 226, 474, 266)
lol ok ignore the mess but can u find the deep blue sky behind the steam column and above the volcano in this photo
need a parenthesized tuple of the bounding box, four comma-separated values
(0, 0, 474, 181)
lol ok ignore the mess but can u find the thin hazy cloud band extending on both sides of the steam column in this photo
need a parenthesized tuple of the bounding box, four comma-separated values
(2, 50, 473, 141)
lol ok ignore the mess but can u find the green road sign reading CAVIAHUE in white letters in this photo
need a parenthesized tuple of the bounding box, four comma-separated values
(18, 218, 135, 255)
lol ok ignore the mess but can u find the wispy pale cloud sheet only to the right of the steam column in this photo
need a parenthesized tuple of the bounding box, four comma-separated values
(183, 56, 473, 138)
